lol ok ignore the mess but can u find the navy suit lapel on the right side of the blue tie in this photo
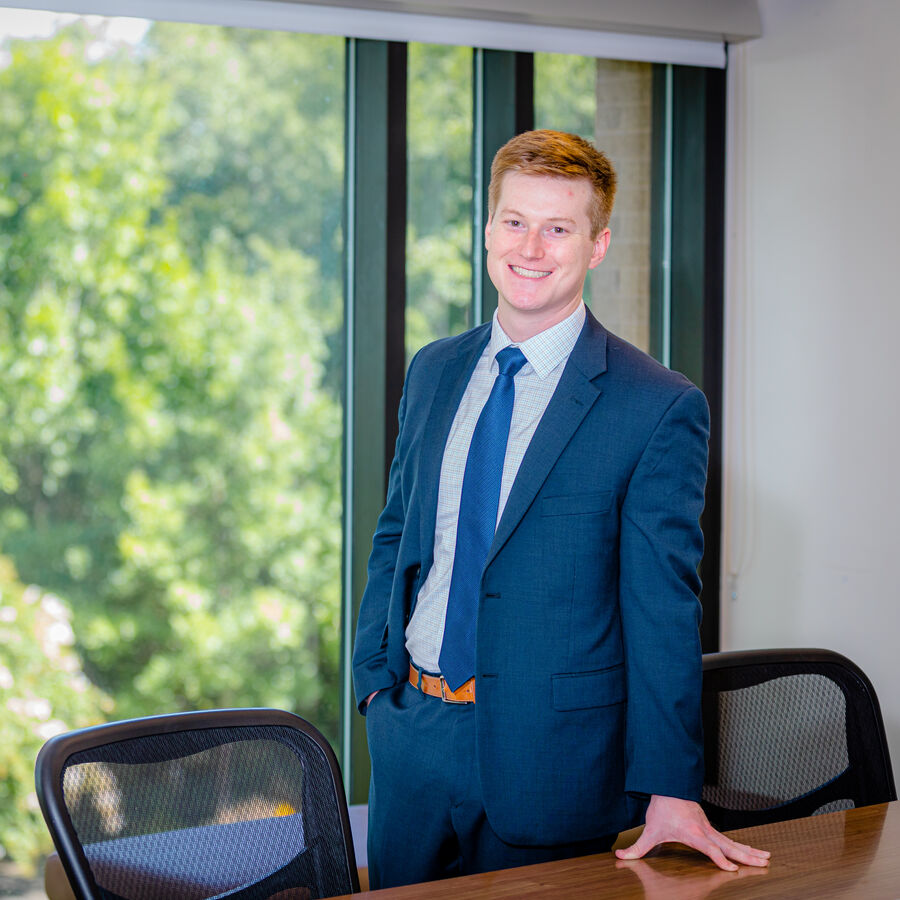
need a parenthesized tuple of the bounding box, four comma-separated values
(485, 310, 606, 566)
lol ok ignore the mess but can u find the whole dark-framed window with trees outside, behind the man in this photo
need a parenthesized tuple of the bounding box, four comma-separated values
(0, 4, 724, 880)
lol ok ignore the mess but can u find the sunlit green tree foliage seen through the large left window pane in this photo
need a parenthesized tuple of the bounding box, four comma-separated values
(0, 25, 343, 856)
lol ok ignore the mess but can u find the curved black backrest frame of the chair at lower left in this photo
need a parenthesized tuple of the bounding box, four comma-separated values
(35, 708, 359, 900)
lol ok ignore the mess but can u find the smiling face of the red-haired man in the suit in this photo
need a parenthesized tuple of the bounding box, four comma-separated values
(484, 172, 609, 341)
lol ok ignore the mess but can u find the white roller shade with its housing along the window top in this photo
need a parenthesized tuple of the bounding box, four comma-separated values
(0, 0, 760, 67)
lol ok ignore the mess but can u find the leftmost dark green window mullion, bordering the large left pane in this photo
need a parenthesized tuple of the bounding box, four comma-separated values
(342, 39, 407, 803)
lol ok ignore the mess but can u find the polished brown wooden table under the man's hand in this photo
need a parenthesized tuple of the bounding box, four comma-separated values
(336, 802, 900, 900)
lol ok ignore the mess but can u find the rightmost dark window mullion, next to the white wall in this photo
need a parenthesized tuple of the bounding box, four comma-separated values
(651, 66, 725, 653)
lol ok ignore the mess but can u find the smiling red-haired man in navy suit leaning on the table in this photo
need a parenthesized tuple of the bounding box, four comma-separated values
(353, 131, 768, 887)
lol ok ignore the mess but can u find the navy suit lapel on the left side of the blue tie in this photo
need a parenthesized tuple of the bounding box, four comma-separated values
(418, 323, 491, 572)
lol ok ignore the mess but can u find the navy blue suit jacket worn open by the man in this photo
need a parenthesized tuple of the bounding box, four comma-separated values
(353, 312, 709, 845)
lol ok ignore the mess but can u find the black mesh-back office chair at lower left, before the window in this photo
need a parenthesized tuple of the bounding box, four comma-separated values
(35, 709, 359, 900)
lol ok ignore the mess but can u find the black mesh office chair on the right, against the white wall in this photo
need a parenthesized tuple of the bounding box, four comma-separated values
(702, 650, 897, 830)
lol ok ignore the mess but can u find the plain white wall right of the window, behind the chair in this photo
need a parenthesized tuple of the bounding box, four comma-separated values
(722, 0, 900, 774)
